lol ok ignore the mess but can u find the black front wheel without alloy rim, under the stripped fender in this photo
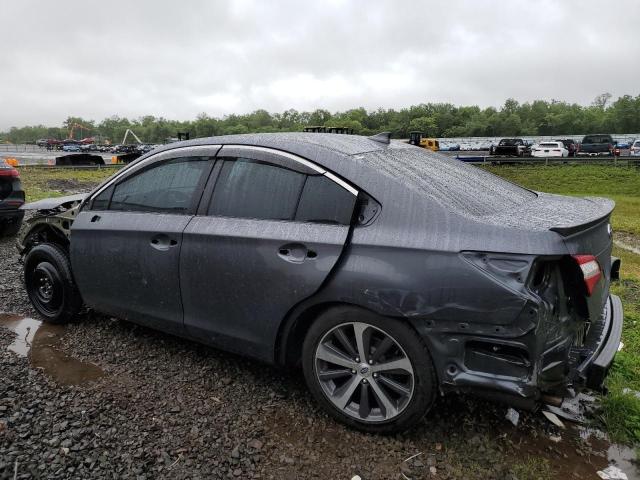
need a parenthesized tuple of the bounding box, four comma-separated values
(24, 243, 82, 323)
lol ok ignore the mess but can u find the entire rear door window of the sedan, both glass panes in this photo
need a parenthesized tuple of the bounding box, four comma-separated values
(208, 158, 356, 225)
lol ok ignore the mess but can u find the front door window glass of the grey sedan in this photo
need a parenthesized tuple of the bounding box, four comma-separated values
(109, 157, 209, 213)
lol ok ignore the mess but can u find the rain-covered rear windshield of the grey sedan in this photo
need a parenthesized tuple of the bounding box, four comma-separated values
(358, 144, 537, 216)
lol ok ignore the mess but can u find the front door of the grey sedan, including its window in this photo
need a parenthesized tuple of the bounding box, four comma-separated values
(71, 148, 217, 333)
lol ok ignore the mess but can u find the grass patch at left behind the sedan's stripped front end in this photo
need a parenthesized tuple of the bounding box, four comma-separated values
(20, 167, 117, 202)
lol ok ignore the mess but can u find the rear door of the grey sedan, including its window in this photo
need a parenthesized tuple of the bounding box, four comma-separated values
(180, 146, 358, 360)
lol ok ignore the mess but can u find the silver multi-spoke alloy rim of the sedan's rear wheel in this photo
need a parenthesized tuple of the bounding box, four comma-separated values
(315, 322, 414, 422)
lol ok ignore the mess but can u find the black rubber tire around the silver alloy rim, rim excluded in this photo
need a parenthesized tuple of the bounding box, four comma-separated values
(302, 306, 438, 434)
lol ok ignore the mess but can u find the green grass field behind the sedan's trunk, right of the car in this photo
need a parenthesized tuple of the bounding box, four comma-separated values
(483, 164, 640, 236)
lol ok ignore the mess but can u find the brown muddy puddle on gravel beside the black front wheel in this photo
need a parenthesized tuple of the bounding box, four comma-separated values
(0, 314, 104, 385)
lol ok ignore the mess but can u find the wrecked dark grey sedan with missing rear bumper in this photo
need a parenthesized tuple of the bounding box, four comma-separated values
(18, 133, 623, 433)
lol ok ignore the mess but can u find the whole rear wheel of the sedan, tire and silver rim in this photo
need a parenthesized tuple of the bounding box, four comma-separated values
(302, 307, 437, 433)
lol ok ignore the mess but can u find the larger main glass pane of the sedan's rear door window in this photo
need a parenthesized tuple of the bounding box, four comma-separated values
(208, 158, 306, 220)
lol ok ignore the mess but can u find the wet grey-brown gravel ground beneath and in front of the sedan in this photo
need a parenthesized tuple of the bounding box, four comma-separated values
(0, 231, 620, 480)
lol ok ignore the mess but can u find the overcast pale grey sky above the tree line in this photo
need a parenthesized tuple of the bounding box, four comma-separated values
(0, 0, 640, 130)
